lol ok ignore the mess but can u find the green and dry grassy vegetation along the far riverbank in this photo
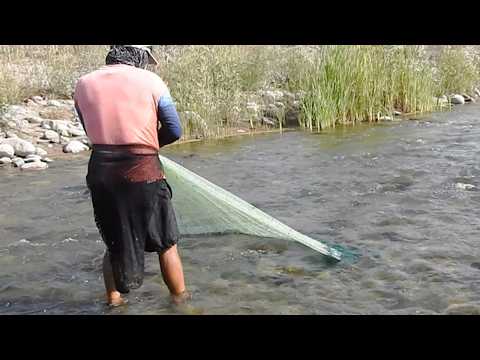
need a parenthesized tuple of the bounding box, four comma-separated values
(0, 45, 480, 138)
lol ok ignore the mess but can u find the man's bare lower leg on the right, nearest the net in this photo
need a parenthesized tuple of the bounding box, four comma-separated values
(159, 245, 189, 304)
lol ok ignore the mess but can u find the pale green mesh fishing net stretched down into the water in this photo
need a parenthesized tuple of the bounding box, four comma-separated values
(160, 156, 341, 260)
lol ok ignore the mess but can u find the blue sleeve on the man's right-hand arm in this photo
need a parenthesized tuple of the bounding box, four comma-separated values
(158, 94, 182, 147)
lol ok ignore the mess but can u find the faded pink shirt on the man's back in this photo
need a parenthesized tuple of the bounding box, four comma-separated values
(74, 65, 169, 151)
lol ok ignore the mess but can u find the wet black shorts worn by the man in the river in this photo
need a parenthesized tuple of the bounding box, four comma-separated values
(87, 148, 180, 293)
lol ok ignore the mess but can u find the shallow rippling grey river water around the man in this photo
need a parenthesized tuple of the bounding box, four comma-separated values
(0, 105, 480, 314)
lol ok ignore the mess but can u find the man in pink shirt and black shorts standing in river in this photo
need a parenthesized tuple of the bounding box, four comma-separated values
(74, 45, 188, 306)
